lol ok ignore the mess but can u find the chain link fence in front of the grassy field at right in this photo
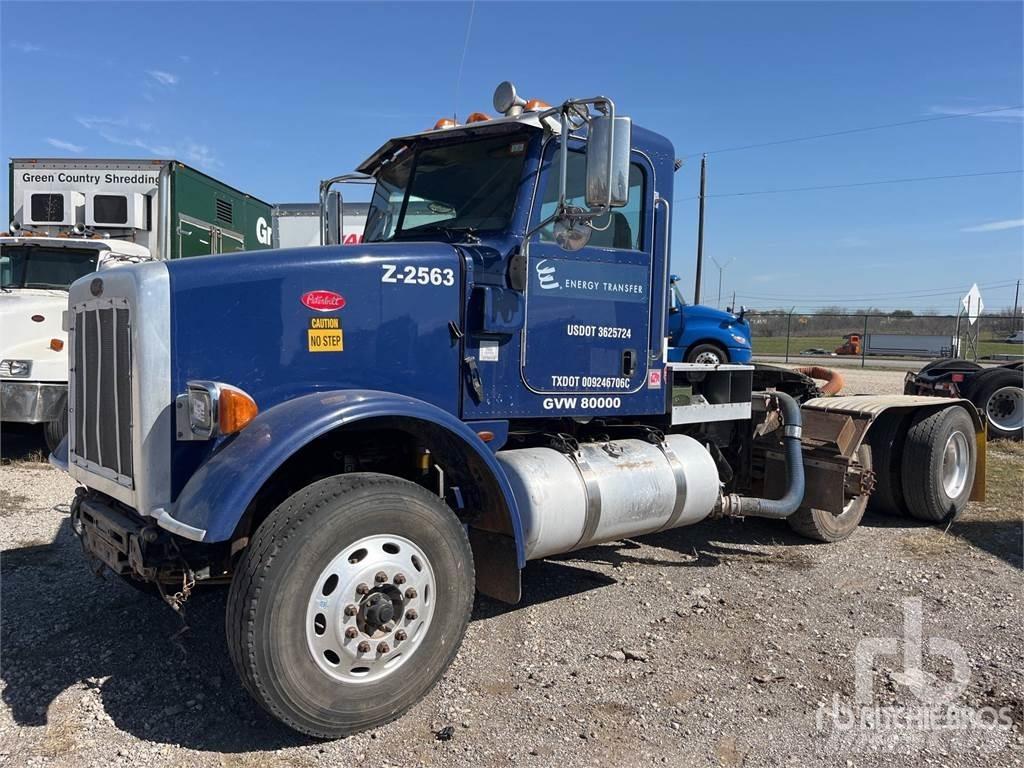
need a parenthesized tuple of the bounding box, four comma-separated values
(746, 310, 1024, 367)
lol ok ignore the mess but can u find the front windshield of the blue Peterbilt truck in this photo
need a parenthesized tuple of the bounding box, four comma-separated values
(364, 135, 526, 243)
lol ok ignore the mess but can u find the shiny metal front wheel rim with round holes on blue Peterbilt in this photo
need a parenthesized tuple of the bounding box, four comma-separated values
(306, 535, 436, 683)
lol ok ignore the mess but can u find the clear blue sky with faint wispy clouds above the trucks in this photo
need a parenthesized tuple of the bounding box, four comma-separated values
(0, 2, 1024, 311)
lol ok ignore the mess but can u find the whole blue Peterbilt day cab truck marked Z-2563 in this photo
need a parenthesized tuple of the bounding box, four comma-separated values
(52, 83, 984, 737)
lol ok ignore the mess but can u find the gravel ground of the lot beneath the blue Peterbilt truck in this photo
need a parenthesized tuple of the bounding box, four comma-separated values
(0, 371, 1024, 768)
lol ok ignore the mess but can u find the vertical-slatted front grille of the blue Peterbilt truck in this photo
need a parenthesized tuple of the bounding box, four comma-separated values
(69, 298, 133, 487)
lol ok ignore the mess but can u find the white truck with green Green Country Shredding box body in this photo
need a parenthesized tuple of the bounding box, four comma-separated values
(0, 158, 271, 451)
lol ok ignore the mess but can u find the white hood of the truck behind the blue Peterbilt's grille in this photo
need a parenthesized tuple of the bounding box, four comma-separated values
(0, 288, 68, 381)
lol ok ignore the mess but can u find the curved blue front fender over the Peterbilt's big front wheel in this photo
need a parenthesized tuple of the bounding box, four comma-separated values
(165, 389, 525, 567)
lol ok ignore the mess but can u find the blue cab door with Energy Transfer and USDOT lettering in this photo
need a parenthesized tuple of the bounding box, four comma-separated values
(521, 141, 653, 402)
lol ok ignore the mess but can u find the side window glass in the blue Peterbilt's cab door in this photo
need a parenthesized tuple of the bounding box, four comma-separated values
(541, 152, 644, 251)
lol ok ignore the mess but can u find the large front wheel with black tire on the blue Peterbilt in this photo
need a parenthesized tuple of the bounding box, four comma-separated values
(226, 473, 474, 738)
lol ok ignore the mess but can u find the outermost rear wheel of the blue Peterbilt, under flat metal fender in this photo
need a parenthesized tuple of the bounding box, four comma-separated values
(901, 406, 977, 522)
